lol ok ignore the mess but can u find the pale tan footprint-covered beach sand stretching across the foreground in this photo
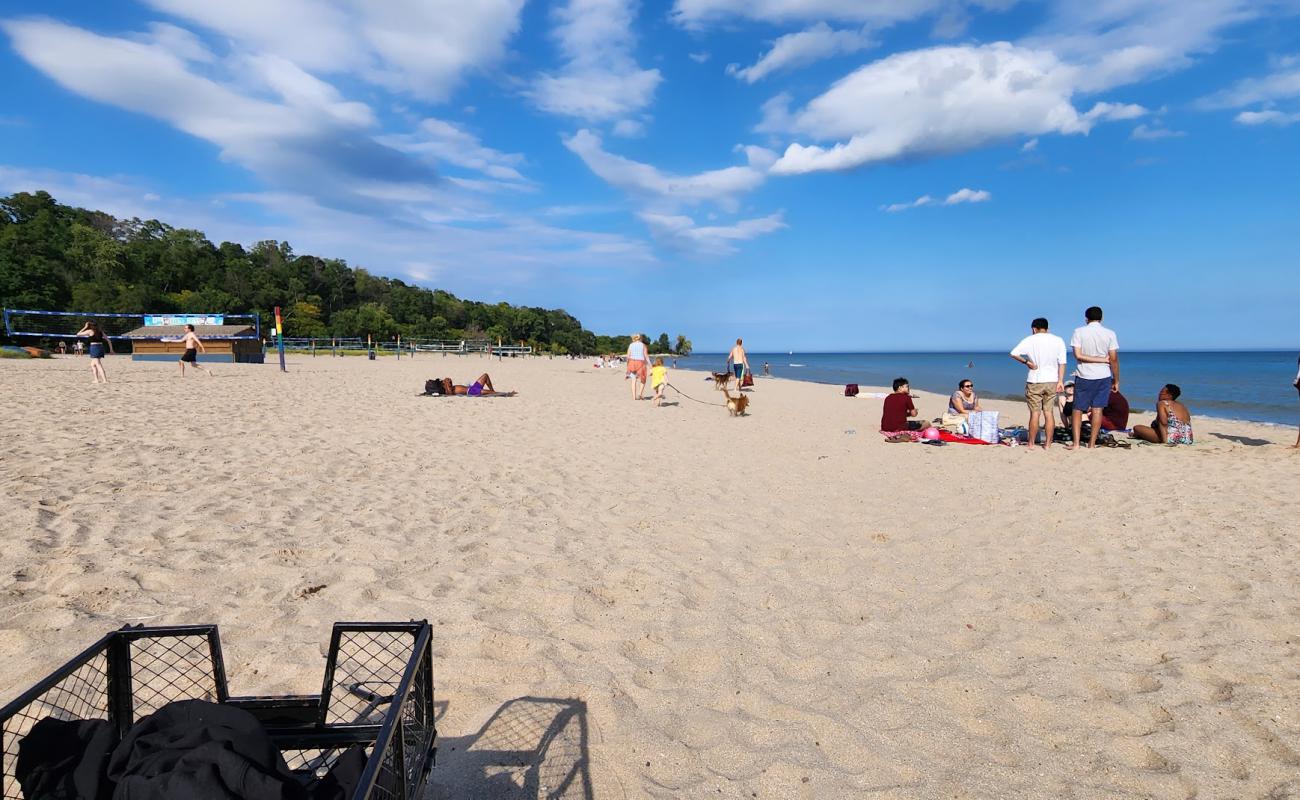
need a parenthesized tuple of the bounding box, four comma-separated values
(0, 355, 1300, 799)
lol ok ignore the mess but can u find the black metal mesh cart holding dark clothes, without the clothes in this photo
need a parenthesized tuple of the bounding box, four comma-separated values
(0, 620, 437, 800)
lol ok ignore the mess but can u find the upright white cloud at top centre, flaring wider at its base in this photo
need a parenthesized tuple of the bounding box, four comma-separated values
(527, 0, 662, 122)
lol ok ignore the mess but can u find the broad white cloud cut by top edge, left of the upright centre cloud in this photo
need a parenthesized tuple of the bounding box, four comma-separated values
(146, 0, 524, 101)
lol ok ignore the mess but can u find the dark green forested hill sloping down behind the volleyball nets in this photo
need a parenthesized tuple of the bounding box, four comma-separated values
(0, 191, 689, 354)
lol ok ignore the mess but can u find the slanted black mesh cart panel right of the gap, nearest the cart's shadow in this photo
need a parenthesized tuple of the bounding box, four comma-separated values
(325, 631, 415, 725)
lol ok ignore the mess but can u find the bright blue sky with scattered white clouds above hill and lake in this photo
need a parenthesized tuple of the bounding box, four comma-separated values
(0, 0, 1300, 350)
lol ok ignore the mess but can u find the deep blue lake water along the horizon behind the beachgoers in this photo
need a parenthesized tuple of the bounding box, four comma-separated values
(677, 350, 1300, 425)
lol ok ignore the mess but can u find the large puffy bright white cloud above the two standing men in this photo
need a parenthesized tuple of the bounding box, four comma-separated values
(761, 42, 1145, 174)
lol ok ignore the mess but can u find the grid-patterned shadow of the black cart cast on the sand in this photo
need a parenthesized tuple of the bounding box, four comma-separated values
(424, 697, 594, 800)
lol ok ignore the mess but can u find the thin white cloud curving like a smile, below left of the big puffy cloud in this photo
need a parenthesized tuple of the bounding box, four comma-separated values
(564, 129, 774, 211)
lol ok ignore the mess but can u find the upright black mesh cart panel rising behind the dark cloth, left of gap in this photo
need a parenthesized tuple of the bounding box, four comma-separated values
(131, 635, 217, 719)
